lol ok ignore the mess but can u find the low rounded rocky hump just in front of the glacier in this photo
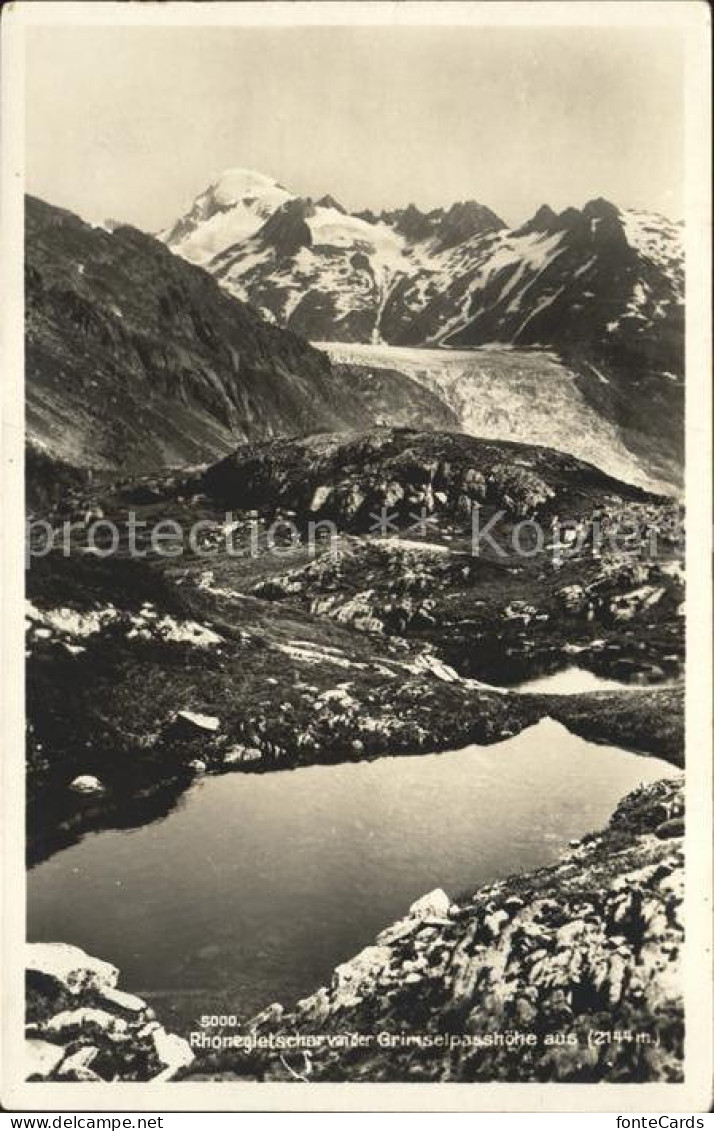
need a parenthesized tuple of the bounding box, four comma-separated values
(191, 428, 668, 520)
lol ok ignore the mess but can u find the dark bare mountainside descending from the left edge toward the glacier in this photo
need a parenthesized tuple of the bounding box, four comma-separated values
(26, 198, 453, 481)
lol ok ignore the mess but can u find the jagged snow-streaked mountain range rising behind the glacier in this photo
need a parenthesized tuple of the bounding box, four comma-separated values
(161, 170, 683, 483)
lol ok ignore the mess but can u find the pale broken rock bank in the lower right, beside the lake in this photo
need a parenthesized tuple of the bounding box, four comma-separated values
(190, 780, 683, 1082)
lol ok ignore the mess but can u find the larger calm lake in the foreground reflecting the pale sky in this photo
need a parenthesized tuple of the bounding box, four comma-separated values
(28, 720, 679, 1013)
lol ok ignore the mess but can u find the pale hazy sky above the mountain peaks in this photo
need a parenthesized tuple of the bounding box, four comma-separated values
(26, 27, 683, 231)
